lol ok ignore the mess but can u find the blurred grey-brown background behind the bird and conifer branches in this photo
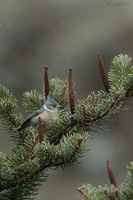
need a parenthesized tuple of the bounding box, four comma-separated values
(0, 0, 133, 200)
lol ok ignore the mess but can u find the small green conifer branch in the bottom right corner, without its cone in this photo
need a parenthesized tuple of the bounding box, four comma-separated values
(78, 162, 133, 200)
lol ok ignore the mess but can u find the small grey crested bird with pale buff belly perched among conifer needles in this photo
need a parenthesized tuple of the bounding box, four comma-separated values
(16, 92, 61, 132)
